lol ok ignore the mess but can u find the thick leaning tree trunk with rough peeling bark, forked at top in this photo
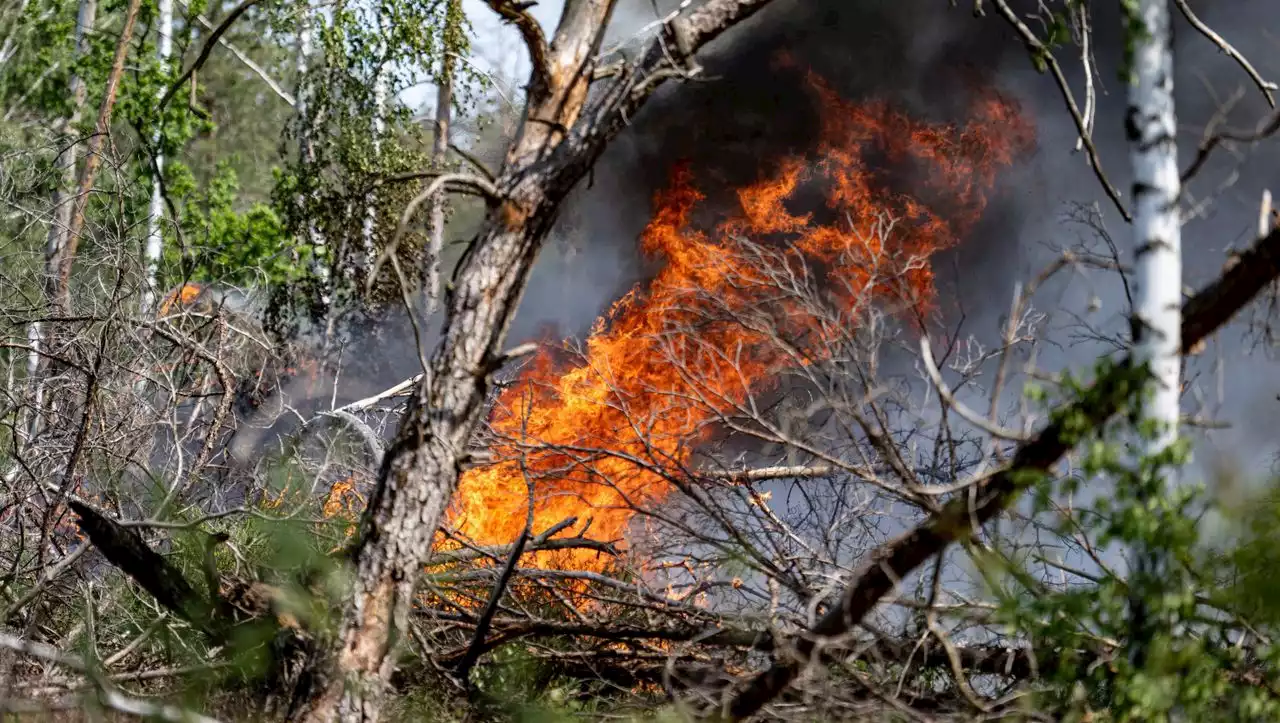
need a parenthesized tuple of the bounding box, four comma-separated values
(291, 0, 771, 723)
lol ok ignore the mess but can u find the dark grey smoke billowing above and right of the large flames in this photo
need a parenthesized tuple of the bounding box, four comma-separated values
(499, 0, 1280, 468)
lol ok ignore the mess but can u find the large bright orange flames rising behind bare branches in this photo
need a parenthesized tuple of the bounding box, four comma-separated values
(449, 70, 1033, 569)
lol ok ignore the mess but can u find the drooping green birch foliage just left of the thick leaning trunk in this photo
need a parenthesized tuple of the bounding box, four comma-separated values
(273, 0, 484, 323)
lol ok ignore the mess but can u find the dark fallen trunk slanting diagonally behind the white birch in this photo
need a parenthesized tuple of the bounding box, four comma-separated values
(721, 222, 1280, 720)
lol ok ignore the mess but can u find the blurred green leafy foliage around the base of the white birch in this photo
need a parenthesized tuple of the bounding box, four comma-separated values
(974, 365, 1280, 722)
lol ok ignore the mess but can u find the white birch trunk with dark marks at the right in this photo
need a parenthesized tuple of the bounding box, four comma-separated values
(1125, 0, 1183, 663)
